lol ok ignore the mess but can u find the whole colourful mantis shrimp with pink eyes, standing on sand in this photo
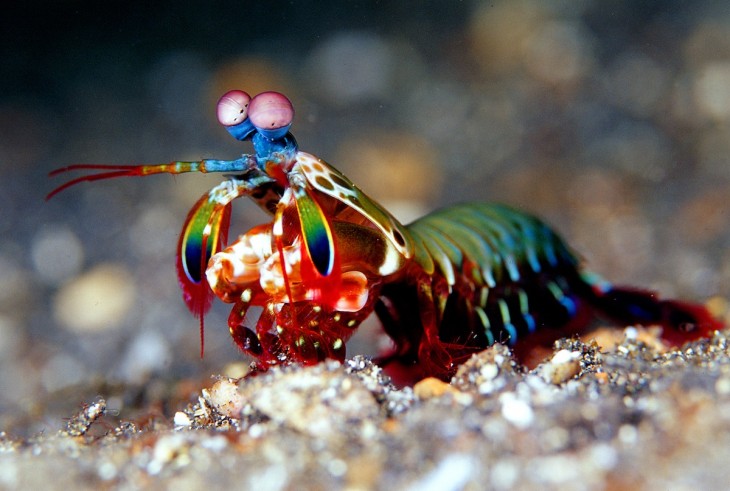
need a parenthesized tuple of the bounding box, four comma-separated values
(47, 90, 722, 379)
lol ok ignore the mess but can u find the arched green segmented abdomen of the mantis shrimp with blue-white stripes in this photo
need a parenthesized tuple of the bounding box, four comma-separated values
(408, 204, 587, 346)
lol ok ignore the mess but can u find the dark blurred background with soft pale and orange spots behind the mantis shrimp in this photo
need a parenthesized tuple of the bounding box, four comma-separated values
(0, 0, 730, 432)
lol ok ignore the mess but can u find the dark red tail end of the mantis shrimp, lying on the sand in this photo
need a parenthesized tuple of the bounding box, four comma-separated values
(590, 284, 724, 346)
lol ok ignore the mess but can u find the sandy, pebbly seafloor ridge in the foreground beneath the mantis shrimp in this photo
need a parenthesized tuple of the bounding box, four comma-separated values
(5, 328, 730, 490)
